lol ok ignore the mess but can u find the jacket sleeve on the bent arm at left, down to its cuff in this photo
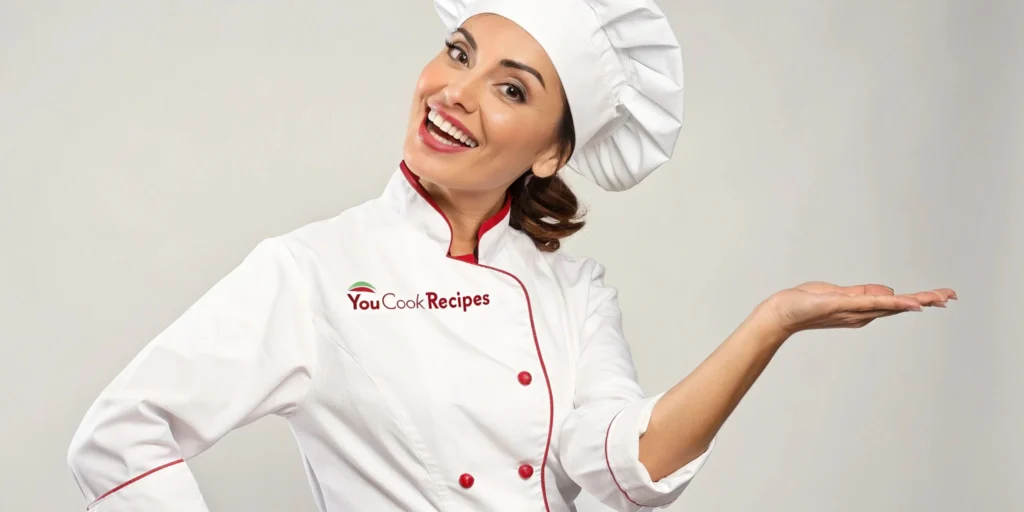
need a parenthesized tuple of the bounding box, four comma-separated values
(68, 239, 315, 512)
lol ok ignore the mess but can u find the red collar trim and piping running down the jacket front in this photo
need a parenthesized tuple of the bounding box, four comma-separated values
(401, 162, 552, 512)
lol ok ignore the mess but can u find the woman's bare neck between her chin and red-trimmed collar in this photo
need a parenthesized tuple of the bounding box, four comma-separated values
(421, 180, 505, 260)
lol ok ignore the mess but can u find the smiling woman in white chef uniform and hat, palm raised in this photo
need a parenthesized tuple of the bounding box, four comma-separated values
(69, 0, 955, 512)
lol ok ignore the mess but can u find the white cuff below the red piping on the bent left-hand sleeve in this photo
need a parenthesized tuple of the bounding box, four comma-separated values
(86, 462, 209, 512)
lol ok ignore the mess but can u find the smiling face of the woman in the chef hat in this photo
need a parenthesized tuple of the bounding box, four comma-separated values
(404, 14, 564, 190)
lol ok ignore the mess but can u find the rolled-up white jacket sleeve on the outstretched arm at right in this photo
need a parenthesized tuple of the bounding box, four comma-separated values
(558, 263, 715, 512)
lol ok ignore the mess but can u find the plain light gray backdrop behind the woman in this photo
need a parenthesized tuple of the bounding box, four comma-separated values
(0, 0, 1024, 512)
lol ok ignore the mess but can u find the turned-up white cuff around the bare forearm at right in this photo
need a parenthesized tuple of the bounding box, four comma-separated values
(604, 393, 718, 507)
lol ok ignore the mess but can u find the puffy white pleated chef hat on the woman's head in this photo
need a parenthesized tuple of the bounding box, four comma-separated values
(434, 0, 683, 190)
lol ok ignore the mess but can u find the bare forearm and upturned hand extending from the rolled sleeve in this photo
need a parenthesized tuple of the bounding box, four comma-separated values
(640, 283, 956, 481)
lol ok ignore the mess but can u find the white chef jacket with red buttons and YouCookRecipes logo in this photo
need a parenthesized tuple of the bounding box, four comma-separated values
(69, 161, 714, 512)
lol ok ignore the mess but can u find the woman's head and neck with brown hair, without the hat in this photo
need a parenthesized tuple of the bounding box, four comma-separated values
(404, 13, 584, 256)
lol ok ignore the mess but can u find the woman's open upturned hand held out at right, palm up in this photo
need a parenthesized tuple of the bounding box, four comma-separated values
(759, 282, 956, 336)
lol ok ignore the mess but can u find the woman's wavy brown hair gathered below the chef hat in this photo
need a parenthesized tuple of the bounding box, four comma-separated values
(509, 96, 585, 252)
